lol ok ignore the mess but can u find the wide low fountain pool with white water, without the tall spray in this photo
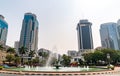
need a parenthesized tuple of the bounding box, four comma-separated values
(8, 66, 106, 72)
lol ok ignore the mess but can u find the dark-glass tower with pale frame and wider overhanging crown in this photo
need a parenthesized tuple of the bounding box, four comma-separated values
(77, 20, 93, 52)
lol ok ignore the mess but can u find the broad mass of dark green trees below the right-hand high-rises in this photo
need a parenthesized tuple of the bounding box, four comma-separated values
(83, 49, 120, 65)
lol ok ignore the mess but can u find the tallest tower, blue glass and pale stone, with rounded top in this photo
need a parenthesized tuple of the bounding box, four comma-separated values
(19, 13, 39, 55)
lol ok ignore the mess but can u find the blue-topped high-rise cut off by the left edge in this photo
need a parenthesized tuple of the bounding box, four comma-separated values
(0, 15, 8, 45)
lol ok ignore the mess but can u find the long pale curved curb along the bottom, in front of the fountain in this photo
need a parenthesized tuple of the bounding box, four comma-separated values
(0, 70, 120, 76)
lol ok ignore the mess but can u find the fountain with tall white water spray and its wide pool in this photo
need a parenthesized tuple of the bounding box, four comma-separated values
(3, 47, 108, 74)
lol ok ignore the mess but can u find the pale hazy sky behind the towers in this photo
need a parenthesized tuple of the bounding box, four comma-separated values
(0, 0, 120, 54)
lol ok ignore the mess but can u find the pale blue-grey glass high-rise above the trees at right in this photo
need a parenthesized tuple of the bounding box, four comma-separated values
(100, 22, 119, 50)
